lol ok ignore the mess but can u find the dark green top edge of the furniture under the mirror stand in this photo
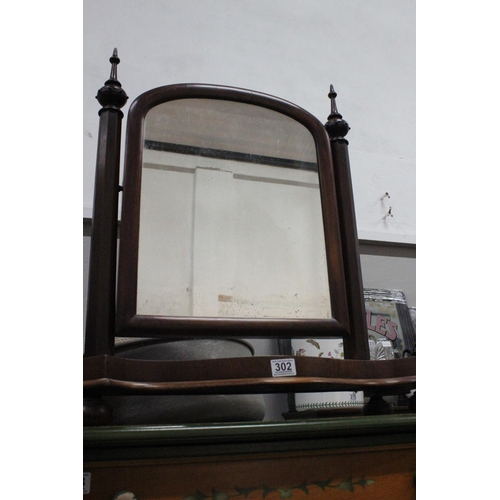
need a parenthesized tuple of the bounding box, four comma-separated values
(83, 414, 416, 461)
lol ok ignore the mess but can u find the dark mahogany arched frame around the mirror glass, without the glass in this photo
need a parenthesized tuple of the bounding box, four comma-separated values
(115, 83, 350, 340)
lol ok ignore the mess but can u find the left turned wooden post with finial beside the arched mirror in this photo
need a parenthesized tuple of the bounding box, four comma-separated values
(84, 49, 128, 357)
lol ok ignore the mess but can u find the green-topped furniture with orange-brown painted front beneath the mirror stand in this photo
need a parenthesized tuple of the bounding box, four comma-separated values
(83, 414, 416, 500)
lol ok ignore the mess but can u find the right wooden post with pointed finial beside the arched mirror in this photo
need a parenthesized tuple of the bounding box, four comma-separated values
(325, 85, 370, 359)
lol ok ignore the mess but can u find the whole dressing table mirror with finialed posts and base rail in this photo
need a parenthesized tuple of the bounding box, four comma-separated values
(84, 51, 416, 425)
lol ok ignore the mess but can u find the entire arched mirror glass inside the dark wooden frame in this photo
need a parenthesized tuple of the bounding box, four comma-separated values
(137, 99, 331, 318)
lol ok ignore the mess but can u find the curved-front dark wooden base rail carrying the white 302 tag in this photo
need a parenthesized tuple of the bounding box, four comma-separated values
(83, 355, 416, 397)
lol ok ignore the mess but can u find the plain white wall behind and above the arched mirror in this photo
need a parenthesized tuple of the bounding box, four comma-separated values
(83, 0, 416, 243)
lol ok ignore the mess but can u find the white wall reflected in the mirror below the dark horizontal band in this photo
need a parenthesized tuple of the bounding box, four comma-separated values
(137, 154, 331, 318)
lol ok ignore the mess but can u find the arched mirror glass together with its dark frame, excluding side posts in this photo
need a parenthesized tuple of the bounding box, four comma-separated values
(117, 84, 349, 344)
